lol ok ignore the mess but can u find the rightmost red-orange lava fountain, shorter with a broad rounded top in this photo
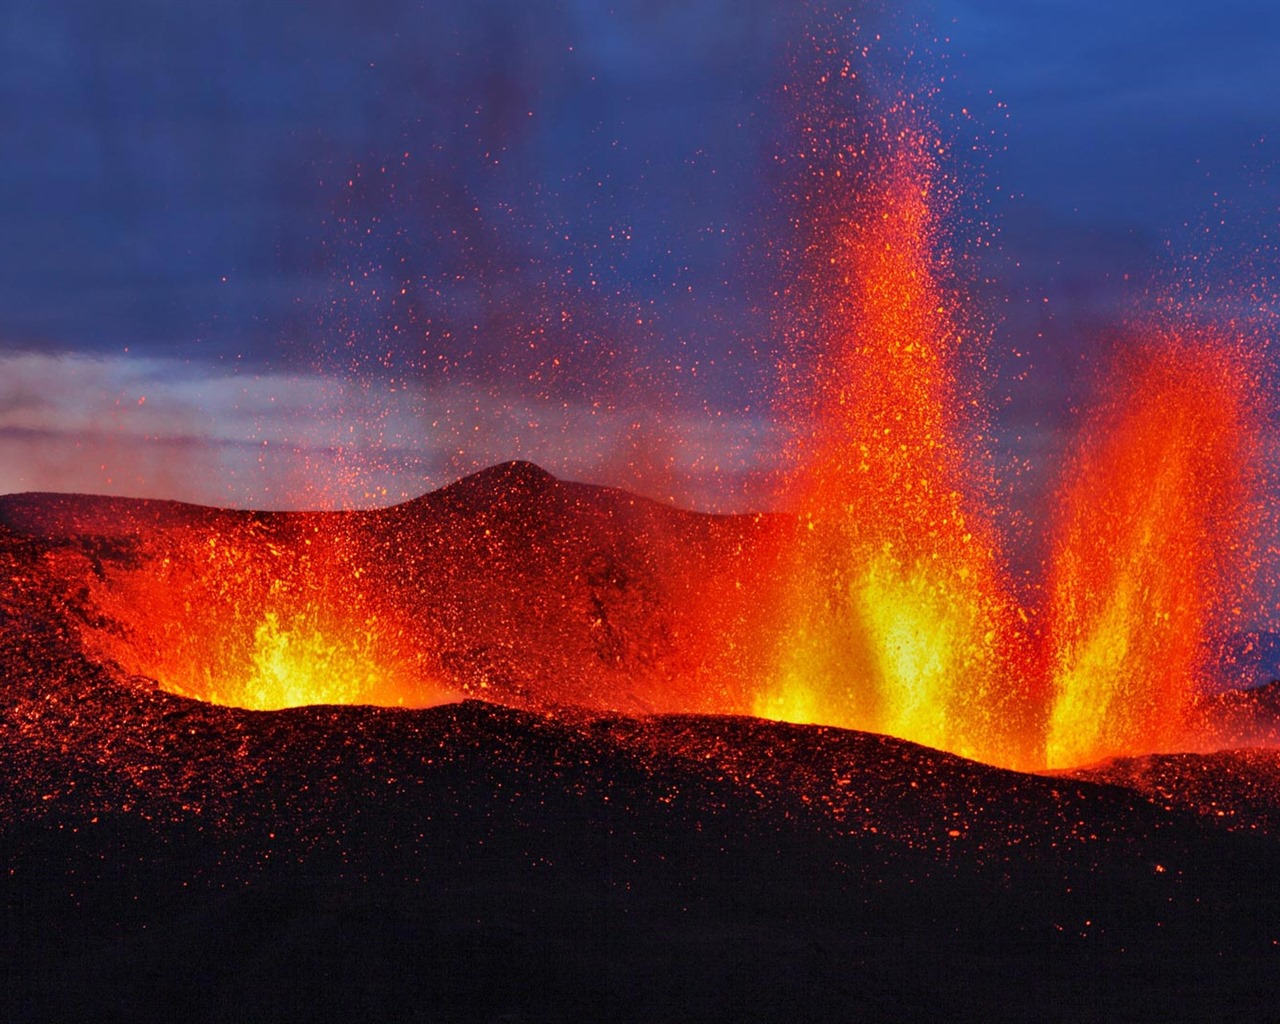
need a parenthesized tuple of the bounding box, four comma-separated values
(1046, 332, 1261, 767)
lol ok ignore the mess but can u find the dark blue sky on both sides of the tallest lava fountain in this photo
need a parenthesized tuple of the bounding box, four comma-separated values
(0, 0, 1280, 502)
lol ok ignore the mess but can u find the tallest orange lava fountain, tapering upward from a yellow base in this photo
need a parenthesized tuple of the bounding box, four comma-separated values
(753, 124, 1036, 764)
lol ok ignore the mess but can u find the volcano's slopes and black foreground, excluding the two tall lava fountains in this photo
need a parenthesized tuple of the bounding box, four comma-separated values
(0, 463, 1280, 1021)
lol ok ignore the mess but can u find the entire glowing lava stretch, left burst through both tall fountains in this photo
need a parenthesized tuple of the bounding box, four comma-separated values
(20, 83, 1261, 768)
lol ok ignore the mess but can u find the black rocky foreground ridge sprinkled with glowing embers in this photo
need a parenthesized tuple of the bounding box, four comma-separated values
(0, 468, 1280, 1021)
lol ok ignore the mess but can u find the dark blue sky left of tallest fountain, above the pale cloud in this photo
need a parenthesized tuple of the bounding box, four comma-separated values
(0, 3, 796, 399)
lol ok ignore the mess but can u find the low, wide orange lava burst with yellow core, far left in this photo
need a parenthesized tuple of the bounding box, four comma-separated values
(77, 515, 448, 710)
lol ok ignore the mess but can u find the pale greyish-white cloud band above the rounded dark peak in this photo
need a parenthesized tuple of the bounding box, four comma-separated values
(0, 352, 783, 512)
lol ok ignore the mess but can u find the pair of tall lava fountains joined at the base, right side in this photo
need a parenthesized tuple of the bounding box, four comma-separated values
(750, 92, 1261, 768)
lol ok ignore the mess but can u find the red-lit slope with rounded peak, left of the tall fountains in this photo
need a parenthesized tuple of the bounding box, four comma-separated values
(0, 462, 762, 710)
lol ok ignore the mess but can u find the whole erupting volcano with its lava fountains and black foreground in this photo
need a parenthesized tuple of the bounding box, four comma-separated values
(0, 8, 1280, 1021)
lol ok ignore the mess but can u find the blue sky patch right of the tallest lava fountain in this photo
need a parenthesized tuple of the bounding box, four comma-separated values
(934, 0, 1280, 389)
